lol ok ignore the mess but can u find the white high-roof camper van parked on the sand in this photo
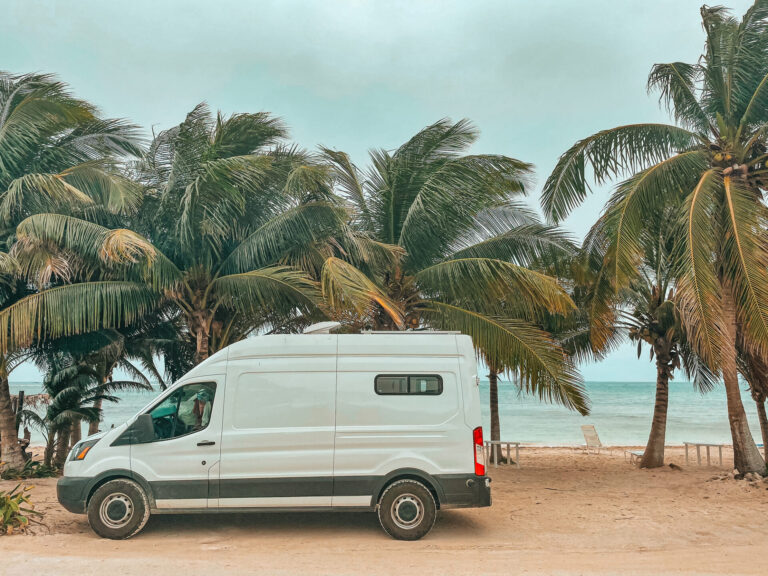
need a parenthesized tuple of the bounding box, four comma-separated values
(57, 332, 491, 540)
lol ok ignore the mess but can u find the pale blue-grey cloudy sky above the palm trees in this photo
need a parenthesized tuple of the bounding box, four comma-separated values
(0, 0, 751, 381)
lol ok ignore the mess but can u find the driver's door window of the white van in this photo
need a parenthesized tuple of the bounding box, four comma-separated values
(149, 382, 216, 440)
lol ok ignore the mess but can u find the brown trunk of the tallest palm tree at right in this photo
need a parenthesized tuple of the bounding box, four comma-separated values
(720, 282, 765, 474)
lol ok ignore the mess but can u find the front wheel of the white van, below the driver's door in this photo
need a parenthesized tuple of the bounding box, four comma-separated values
(88, 478, 149, 540)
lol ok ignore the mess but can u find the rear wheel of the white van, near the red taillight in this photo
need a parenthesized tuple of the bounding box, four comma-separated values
(378, 480, 437, 540)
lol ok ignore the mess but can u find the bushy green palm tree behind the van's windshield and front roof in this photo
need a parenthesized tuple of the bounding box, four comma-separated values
(12, 105, 396, 362)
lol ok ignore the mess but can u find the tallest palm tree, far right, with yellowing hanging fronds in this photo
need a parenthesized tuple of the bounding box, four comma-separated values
(542, 0, 768, 473)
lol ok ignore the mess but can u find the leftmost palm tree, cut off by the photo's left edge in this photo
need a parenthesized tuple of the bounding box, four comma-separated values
(0, 72, 140, 467)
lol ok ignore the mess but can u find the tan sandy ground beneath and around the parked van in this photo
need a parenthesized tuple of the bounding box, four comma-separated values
(0, 448, 768, 576)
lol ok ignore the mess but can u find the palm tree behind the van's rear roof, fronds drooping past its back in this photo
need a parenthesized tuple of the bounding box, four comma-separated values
(323, 120, 588, 420)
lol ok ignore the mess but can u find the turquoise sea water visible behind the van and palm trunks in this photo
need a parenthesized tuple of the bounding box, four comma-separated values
(11, 381, 760, 445)
